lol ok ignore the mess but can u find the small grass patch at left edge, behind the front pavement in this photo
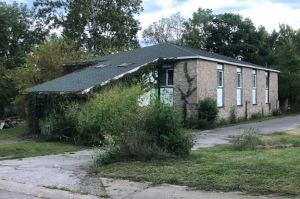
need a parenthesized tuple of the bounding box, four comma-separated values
(0, 123, 83, 159)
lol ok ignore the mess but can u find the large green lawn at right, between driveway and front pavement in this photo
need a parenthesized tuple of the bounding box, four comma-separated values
(97, 134, 300, 196)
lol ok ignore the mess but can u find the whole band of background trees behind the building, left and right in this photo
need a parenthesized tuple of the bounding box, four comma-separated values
(0, 0, 300, 117)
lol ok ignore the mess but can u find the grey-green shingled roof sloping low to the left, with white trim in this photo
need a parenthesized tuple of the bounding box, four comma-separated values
(25, 44, 279, 93)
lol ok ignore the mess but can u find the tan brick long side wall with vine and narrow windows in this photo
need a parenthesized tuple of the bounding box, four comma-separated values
(174, 60, 279, 119)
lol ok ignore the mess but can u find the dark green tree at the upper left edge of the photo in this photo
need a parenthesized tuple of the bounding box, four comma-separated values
(0, 2, 48, 68)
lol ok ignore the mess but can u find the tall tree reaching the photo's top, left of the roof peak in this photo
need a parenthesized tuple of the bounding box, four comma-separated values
(34, 0, 142, 55)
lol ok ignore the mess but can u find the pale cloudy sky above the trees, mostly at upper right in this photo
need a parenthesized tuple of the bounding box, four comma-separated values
(6, 0, 300, 38)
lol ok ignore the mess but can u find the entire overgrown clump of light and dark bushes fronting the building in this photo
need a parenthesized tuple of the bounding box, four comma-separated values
(43, 86, 192, 165)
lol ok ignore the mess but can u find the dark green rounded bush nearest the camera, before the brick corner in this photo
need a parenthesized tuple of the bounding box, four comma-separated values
(96, 102, 192, 166)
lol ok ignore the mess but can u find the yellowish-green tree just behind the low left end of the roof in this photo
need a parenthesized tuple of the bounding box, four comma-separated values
(9, 38, 87, 91)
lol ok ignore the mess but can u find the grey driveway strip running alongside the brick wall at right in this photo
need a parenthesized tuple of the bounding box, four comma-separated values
(194, 115, 300, 148)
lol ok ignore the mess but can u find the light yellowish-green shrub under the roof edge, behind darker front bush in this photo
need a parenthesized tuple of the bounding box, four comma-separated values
(78, 86, 142, 144)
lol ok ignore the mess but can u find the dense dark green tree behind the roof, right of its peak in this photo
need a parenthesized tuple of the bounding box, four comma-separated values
(183, 8, 271, 65)
